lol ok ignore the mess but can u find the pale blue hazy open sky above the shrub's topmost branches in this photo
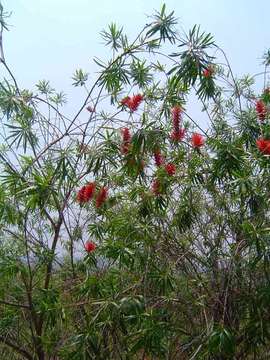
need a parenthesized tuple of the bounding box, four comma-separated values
(0, 0, 270, 119)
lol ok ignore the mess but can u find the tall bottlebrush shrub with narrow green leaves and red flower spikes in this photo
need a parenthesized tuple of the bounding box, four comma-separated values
(0, 2, 270, 360)
